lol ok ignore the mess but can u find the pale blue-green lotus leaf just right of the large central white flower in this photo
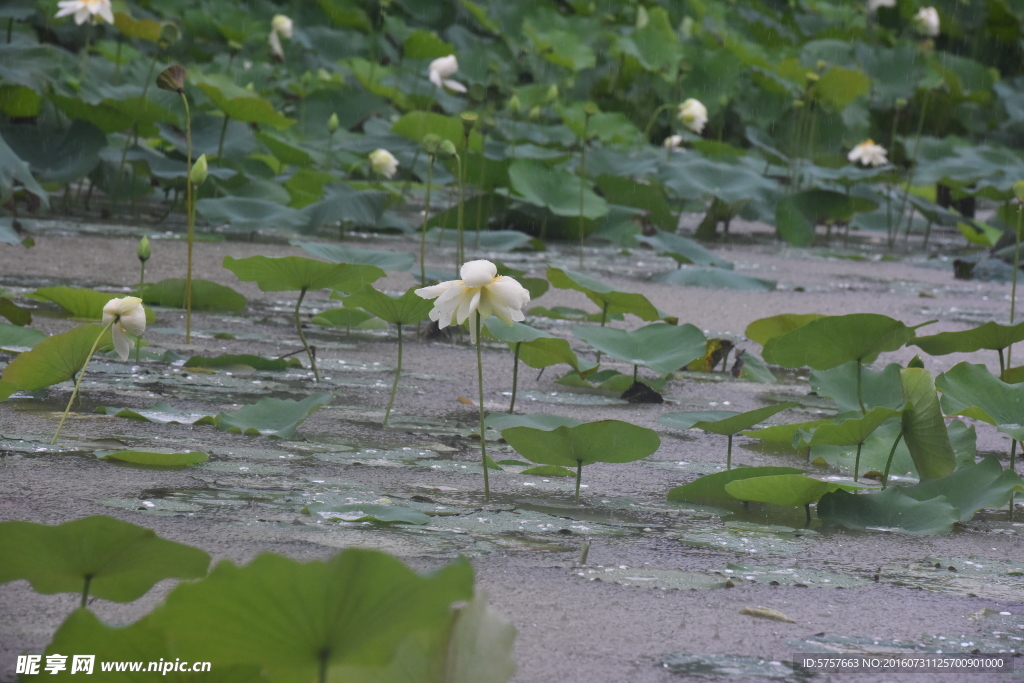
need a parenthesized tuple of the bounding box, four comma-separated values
(572, 323, 708, 373)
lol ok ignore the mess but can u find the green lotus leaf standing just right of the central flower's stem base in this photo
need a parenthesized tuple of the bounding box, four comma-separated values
(502, 420, 662, 468)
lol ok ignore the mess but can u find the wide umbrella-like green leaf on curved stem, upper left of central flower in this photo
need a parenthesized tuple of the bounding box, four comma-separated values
(224, 256, 385, 292)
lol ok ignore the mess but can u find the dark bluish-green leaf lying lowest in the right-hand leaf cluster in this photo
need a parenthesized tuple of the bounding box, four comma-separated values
(818, 486, 961, 535)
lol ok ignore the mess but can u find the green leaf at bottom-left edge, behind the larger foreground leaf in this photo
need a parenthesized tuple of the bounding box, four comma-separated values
(0, 516, 210, 602)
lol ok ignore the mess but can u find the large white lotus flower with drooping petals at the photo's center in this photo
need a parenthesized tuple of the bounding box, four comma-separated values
(416, 259, 529, 343)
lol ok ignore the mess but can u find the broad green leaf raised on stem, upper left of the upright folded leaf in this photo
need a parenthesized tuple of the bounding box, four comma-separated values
(762, 313, 913, 370)
